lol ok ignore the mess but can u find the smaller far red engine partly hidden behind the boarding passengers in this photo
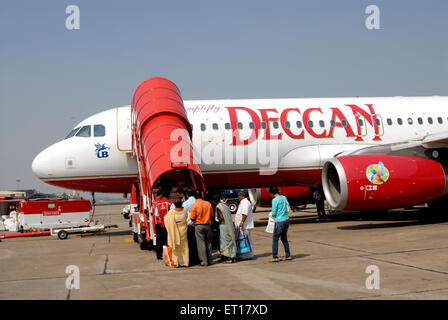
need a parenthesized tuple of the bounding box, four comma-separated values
(248, 187, 313, 207)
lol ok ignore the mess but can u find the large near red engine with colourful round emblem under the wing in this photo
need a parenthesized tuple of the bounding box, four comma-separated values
(322, 155, 447, 211)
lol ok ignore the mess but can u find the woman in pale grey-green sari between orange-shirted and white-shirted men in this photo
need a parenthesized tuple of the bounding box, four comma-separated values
(212, 194, 236, 263)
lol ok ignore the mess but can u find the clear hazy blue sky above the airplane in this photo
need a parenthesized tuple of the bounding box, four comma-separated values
(0, 0, 448, 196)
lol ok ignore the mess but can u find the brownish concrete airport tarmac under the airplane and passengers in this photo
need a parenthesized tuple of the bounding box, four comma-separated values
(0, 205, 448, 300)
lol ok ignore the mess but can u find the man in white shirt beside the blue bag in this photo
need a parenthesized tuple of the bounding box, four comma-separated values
(235, 191, 254, 260)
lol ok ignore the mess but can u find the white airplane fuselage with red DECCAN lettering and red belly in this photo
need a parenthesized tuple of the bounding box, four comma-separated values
(32, 97, 448, 192)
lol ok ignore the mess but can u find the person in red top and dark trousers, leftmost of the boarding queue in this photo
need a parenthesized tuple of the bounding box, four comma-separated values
(154, 190, 174, 260)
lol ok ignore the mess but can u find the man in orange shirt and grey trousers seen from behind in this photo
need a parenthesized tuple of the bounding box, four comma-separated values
(190, 192, 213, 266)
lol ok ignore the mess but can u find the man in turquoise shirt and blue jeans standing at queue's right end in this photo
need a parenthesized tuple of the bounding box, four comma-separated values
(269, 187, 292, 262)
